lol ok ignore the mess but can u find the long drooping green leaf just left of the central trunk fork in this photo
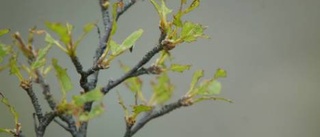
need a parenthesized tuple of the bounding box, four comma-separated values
(52, 59, 73, 94)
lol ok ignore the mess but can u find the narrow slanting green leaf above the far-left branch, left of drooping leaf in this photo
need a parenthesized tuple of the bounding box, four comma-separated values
(31, 44, 52, 70)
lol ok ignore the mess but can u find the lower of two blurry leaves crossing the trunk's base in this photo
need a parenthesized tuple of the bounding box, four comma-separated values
(79, 105, 105, 121)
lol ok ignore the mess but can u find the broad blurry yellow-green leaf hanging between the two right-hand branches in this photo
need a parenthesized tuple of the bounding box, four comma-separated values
(151, 73, 174, 104)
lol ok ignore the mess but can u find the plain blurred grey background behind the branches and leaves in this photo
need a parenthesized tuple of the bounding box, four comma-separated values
(0, 0, 320, 137)
